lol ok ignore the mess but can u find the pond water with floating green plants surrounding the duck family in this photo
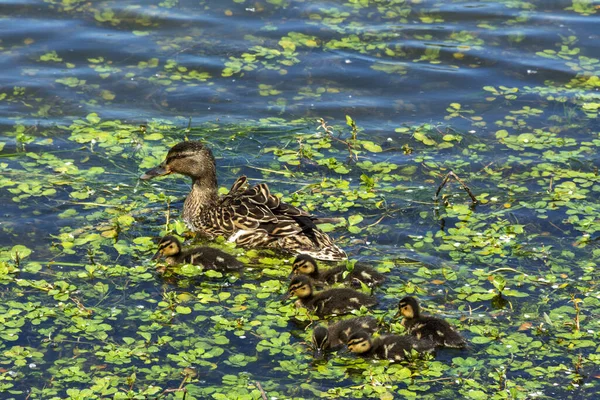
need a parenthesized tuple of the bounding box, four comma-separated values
(0, 0, 600, 399)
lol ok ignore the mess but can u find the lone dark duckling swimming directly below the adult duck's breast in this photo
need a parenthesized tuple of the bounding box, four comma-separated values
(152, 235, 244, 271)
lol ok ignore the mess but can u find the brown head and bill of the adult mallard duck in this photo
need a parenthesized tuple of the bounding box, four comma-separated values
(140, 141, 217, 186)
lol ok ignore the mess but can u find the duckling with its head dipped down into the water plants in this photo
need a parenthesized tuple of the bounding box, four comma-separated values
(313, 317, 377, 357)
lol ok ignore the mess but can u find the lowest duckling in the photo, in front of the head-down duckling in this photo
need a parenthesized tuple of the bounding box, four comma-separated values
(347, 331, 435, 361)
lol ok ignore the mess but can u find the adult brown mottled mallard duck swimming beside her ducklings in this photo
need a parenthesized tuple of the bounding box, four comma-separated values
(140, 141, 346, 260)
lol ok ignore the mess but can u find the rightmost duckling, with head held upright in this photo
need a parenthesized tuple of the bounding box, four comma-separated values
(396, 296, 467, 348)
